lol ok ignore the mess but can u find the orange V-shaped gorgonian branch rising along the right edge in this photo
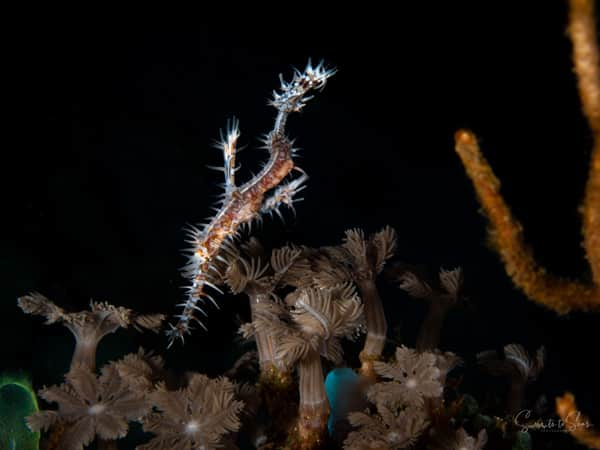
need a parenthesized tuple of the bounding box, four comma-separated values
(455, 0, 600, 314)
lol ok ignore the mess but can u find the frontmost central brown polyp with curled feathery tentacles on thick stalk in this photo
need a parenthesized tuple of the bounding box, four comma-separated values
(246, 284, 363, 443)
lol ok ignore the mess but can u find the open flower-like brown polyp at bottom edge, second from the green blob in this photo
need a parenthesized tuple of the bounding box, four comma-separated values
(138, 374, 244, 450)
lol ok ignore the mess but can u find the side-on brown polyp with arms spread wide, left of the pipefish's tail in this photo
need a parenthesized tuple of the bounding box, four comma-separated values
(18, 292, 165, 372)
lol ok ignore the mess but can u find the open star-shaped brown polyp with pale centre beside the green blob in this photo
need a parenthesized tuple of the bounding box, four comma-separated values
(27, 364, 150, 450)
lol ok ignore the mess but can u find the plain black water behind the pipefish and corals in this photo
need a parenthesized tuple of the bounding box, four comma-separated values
(0, 2, 600, 444)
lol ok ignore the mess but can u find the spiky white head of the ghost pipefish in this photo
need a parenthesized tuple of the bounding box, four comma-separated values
(269, 59, 337, 113)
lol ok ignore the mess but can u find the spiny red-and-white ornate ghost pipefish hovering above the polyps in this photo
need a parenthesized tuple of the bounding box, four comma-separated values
(167, 62, 335, 345)
